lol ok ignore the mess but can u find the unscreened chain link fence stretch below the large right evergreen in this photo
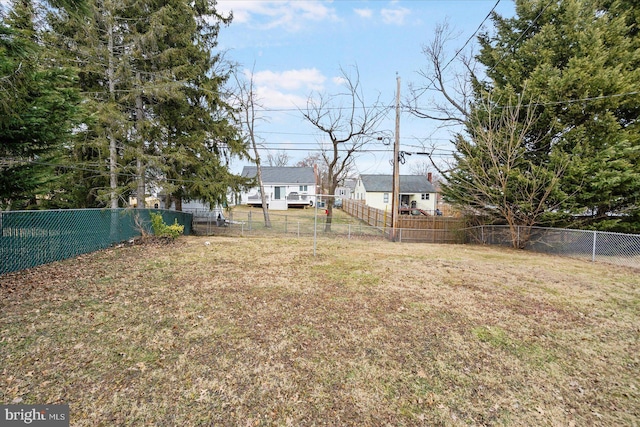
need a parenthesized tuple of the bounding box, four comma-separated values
(468, 225, 640, 268)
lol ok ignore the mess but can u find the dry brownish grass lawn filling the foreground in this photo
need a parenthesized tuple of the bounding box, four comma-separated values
(0, 237, 640, 426)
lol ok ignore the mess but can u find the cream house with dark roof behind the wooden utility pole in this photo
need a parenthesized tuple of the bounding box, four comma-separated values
(354, 175, 437, 215)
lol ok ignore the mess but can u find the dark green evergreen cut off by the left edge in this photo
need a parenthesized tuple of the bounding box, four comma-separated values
(0, 0, 79, 209)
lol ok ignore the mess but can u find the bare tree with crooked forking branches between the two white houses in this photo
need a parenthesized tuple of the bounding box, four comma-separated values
(301, 67, 386, 232)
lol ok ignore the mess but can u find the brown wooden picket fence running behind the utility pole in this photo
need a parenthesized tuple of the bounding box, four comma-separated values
(342, 200, 467, 243)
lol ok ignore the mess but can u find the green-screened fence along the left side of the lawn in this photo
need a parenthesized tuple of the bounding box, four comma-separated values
(0, 209, 192, 274)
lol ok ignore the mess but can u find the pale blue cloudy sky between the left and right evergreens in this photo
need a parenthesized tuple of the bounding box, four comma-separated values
(217, 0, 514, 174)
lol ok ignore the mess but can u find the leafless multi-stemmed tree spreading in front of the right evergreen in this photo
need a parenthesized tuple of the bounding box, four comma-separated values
(442, 95, 567, 248)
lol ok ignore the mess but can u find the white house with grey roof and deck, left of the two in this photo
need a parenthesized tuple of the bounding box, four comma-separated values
(240, 166, 317, 210)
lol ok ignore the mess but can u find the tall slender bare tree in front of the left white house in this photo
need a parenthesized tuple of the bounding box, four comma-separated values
(234, 67, 271, 228)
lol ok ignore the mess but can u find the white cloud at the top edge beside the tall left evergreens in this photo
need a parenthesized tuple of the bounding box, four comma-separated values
(217, 0, 338, 31)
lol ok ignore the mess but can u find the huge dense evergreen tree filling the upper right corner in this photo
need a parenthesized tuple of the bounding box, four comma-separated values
(476, 0, 640, 231)
